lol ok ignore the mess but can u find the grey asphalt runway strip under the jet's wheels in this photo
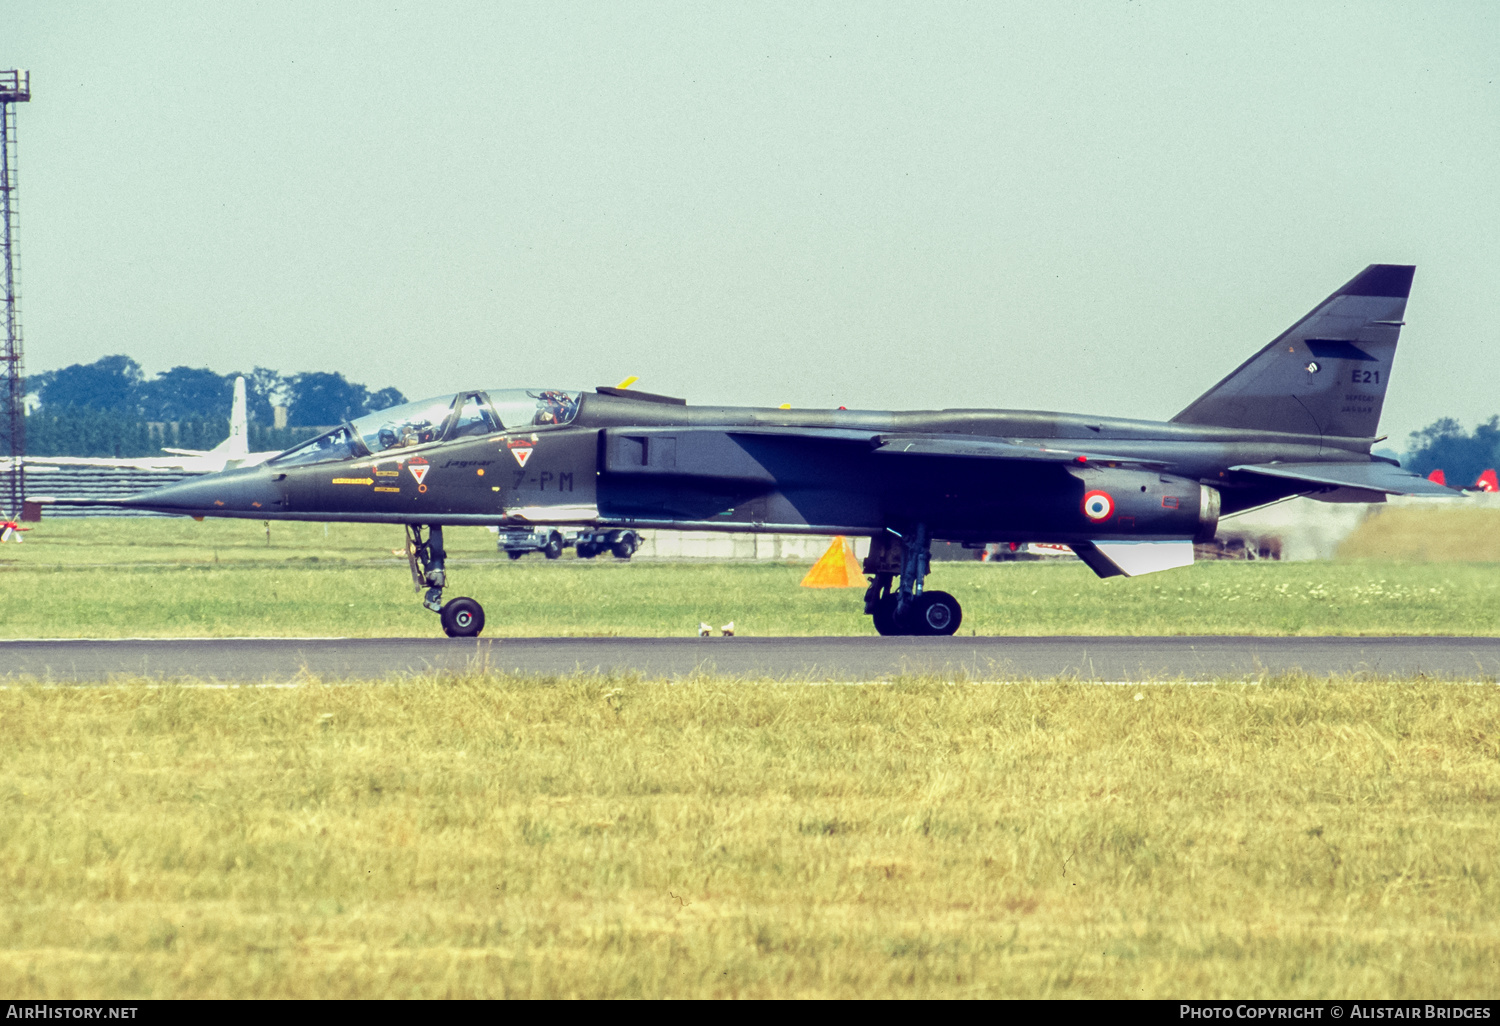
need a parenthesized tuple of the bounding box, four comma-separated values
(0, 638, 1500, 684)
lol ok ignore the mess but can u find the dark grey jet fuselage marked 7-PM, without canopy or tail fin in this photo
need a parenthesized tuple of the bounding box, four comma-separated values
(129, 393, 1370, 543)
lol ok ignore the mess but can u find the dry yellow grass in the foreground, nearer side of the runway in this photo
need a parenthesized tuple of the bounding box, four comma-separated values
(0, 678, 1500, 998)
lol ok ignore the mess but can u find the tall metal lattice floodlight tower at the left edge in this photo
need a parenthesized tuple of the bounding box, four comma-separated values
(0, 71, 32, 519)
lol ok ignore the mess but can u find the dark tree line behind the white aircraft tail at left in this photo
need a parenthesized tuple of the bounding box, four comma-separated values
(26, 356, 407, 458)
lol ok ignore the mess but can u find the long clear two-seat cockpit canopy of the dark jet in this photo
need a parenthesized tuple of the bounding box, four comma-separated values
(269, 389, 584, 467)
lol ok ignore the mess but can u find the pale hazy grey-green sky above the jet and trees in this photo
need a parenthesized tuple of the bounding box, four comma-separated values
(11, 0, 1500, 444)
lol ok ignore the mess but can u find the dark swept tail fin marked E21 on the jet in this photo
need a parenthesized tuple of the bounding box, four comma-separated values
(1172, 264, 1416, 440)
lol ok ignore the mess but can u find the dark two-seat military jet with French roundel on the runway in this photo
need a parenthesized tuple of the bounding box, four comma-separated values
(43, 264, 1457, 636)
